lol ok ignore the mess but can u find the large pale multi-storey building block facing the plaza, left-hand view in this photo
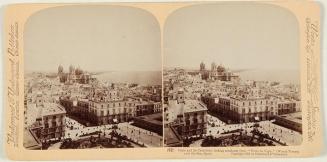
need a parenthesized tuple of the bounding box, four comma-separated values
(60, 89, 162, 125)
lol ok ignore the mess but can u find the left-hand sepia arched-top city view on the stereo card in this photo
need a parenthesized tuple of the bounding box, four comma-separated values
(23, 5, 163, 150)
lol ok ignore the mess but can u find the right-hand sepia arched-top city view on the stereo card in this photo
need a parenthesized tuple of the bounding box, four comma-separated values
(163, 3, 302, 147)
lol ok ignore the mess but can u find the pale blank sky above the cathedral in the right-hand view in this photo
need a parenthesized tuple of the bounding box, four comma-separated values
(163, 3, 300, 70)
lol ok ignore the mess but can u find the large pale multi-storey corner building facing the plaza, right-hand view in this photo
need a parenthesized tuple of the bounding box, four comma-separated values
(202, 87, 278, 123)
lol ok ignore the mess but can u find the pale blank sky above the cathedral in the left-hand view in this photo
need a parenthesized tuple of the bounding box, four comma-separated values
(24, 6, 161, 72)
